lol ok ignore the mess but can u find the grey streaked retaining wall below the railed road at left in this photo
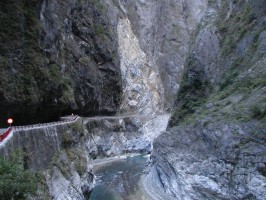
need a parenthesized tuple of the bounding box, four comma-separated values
(1, 119, 82, 170)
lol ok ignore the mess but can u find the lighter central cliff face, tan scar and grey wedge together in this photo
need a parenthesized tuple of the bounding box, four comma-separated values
(112, 0, 207, 113)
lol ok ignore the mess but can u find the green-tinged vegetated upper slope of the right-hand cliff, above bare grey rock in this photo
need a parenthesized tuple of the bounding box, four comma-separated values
(170, 1, 266, 126)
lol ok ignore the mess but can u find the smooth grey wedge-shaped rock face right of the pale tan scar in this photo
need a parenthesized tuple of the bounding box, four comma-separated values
(119, 0, 207, 110)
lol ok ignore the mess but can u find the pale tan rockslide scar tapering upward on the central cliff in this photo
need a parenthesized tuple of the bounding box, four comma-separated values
(117, 18, 164, 114)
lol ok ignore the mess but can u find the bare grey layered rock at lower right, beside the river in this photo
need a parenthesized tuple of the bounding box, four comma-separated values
(143, 123, 265, 199)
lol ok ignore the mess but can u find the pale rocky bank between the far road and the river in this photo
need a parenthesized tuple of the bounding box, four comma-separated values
(84, 115, 170, 158)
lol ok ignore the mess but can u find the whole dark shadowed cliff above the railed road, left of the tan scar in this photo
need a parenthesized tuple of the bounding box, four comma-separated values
(0, 0, 121, 124)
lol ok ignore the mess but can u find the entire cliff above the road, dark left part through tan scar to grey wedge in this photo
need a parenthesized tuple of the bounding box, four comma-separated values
(0, 0, 206, 126)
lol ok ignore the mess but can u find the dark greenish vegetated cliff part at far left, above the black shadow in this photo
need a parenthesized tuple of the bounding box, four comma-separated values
(0, 0, 71, 105)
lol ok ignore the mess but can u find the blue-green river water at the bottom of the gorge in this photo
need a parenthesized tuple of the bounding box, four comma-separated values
(89, 155, 147, 200)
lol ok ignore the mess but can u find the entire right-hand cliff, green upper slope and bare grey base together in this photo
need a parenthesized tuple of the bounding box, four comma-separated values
(143, 0, 266, 199)
